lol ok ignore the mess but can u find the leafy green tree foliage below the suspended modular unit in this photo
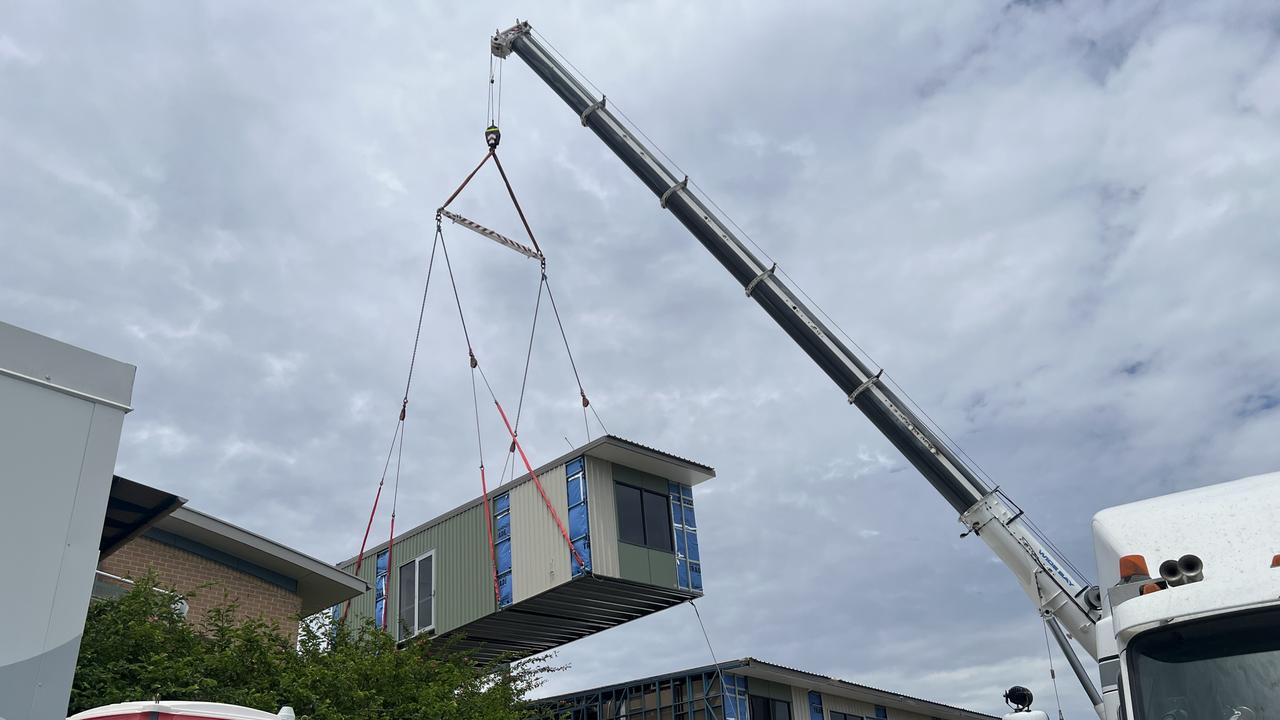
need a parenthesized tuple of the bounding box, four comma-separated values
(69, 578, 556, 720)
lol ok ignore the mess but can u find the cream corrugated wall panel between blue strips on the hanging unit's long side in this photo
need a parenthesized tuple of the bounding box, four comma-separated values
(511, 465, 570, 602)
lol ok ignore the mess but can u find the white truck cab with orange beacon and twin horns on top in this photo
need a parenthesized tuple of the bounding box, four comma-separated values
(1093, 473, 1280, 720)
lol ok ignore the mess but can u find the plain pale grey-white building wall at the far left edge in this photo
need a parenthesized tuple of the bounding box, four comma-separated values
(0, 323, 134, 720)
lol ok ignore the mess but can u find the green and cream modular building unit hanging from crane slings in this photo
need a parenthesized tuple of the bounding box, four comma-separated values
(334, 436, 716, 659)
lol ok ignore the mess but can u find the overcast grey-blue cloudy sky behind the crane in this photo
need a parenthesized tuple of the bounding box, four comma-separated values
(0, 0, 1280, 719)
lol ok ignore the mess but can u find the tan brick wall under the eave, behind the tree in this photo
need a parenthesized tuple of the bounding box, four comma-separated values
(97, 537, 302, 637)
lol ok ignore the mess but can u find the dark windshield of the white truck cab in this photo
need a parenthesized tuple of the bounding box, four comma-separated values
(1129, 609, 1280, 720)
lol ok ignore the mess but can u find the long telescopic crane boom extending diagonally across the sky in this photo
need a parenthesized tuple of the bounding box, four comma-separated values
(492, 23, 1098, 659)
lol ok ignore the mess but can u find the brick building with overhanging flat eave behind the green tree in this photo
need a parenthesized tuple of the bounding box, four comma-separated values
(93, 481, 367, 635)
